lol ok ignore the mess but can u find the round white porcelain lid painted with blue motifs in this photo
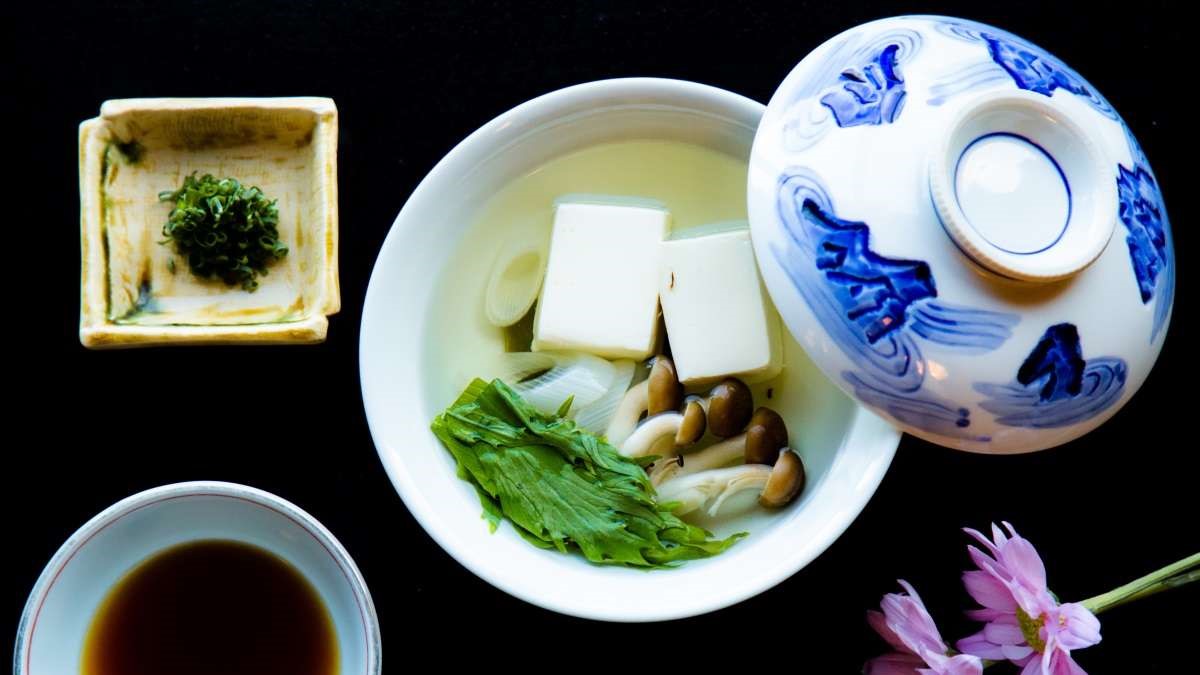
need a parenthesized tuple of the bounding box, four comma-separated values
(748, 17, 1175, 453)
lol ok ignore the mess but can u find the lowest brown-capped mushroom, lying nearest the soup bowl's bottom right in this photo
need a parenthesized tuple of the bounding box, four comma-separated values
(658, 448, 804, 516)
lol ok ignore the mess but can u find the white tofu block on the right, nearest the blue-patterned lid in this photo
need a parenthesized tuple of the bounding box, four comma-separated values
(659, 229, 782, 384)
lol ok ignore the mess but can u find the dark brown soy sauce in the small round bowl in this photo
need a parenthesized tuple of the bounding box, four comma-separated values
(83, 539, 338, 675)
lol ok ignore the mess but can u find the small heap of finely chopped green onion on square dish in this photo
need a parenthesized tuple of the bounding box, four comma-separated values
(158, 173, 288, 291)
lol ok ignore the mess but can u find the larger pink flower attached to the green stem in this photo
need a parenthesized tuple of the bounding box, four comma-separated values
(955, 522, 1100, 675)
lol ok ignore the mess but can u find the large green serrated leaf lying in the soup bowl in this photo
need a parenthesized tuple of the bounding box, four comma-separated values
(432, 380, 744, 567)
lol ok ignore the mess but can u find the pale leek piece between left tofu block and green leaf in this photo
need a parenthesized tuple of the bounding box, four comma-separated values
(500, 352, 616, 414)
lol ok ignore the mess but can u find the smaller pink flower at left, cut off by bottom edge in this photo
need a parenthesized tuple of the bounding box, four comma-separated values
(863, 580, 983, 675)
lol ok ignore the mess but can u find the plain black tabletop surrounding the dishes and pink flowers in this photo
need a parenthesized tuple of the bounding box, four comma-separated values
(0, 0, 1200, 674)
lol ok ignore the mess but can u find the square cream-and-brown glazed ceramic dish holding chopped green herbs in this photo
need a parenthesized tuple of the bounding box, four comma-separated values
(79, 97, 341, 348)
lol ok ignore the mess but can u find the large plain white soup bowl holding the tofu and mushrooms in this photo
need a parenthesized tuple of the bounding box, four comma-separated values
(360, 79, 899, 621)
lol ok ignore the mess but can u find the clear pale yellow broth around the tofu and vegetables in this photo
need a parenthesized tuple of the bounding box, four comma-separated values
(424, 141, 852, 536)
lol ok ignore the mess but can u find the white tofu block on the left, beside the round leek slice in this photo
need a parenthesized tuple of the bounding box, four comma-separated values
(533, 203, 671, 359)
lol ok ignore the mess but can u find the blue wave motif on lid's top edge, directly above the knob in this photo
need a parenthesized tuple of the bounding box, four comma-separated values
(934, 19, 1120, 120)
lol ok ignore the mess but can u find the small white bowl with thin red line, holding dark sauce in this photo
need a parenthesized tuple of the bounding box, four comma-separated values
(13, 482, 382, 675)
